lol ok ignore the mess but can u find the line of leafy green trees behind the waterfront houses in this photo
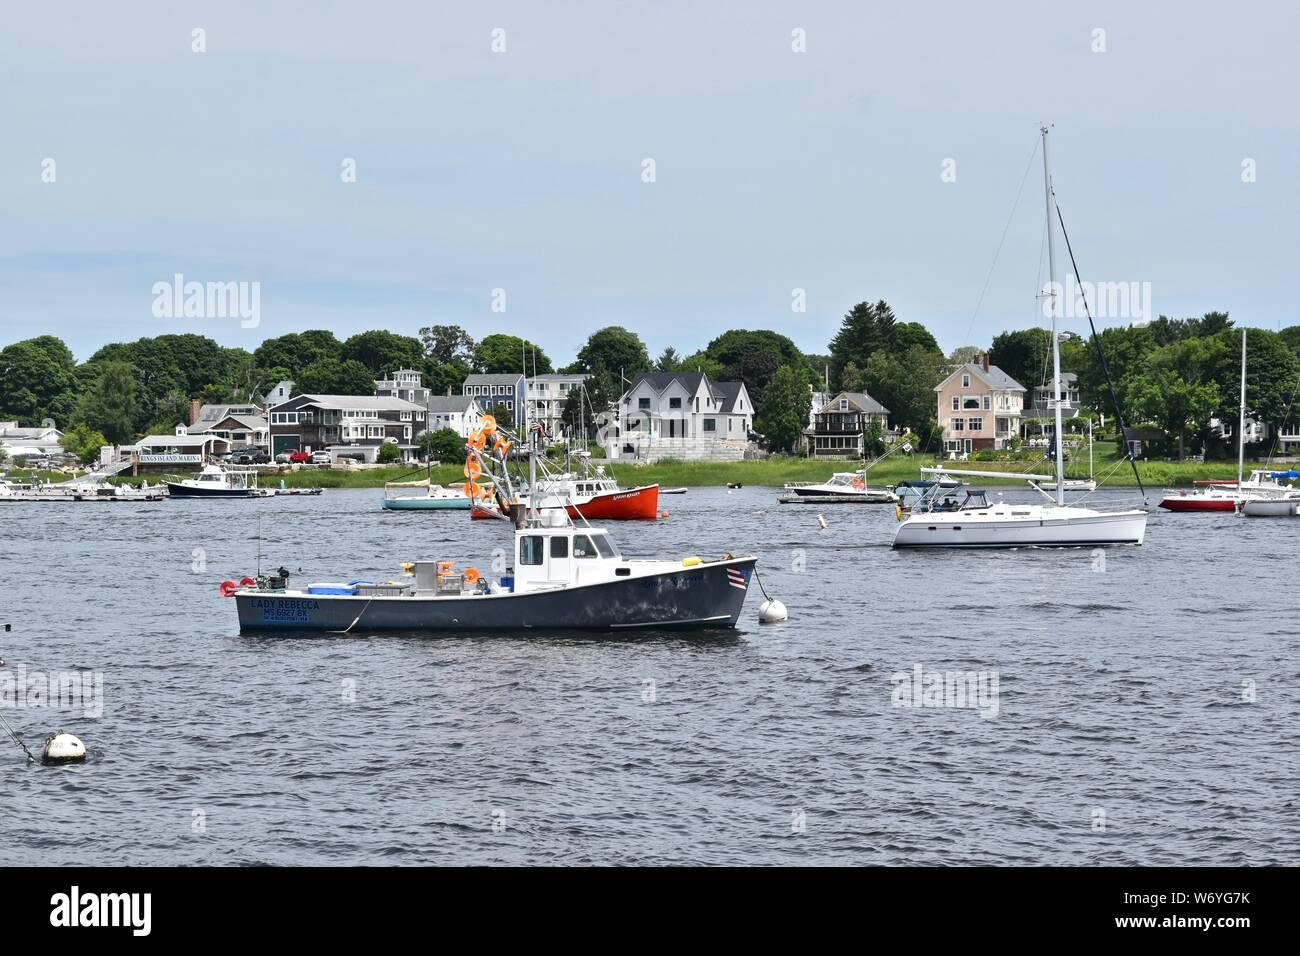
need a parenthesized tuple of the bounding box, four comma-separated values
(0, 300, 1300, 454)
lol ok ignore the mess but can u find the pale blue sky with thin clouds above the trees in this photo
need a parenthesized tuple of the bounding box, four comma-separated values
(0, 0, 1300, 362)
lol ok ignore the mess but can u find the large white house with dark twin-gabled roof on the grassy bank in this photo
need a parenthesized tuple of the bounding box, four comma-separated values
(603, 372, 754, 462)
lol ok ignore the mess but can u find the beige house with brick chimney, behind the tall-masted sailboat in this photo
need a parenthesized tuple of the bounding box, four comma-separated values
(935, 352, 1024, 455)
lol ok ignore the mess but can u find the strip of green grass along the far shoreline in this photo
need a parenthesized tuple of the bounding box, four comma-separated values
(10, 455, 1291, 488)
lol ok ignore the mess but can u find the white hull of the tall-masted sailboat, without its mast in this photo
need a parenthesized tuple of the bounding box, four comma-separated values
(893, 507, 1147, 548)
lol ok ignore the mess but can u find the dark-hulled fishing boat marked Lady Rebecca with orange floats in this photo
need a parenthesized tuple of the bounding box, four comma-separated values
(221, 416, 757, 633)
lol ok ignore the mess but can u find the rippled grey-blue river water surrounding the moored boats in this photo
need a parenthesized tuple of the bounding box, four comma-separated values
(0, 488, 1300, 865)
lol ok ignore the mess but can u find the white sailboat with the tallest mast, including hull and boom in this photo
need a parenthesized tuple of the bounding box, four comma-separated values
(893, 126, 1147, 548)
